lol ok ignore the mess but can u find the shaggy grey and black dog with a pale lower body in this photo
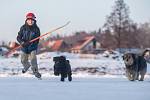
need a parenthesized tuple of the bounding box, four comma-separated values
(123, 52, 147, 81)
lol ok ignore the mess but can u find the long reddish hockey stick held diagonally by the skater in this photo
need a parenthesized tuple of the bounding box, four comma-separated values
(5, 21, 70, 57)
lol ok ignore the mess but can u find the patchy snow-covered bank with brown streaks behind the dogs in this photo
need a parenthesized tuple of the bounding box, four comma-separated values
(0, 52, 150, 77)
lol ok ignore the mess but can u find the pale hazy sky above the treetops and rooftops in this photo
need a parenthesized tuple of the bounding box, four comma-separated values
(0, 0, 150, 41)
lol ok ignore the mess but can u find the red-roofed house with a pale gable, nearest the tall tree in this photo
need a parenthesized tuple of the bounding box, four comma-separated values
(71, 36, 101, 53)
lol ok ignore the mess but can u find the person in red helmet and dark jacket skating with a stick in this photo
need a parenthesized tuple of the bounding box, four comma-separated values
(17, 13, 41, 78)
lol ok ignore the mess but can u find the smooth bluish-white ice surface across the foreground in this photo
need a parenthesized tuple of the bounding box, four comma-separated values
(0, 77, 150, 100)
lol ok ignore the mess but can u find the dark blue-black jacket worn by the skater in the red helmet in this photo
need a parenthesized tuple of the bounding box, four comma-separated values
(17, 21, 40, 54)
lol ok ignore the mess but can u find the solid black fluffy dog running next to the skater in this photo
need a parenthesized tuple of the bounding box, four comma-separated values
(53, 56, 72, 81)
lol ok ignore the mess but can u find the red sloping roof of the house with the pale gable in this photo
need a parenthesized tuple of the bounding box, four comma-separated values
(72, 36, 95, 50)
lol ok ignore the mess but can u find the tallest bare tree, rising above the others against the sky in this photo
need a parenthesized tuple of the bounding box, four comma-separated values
(104, 0, 132, 51)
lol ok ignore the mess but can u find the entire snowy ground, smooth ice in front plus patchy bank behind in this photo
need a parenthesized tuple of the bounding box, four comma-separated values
(0, 53, 150, 100)
